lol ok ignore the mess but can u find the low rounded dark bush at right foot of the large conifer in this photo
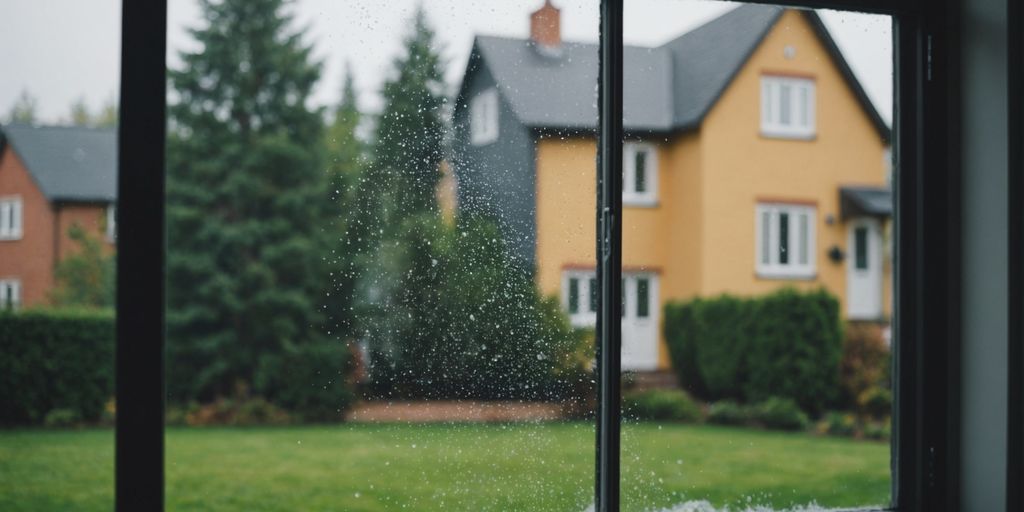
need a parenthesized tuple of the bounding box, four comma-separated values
(254, 341, 354, 422)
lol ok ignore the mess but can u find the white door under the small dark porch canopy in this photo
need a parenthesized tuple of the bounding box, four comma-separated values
(846, 218, 882, 319)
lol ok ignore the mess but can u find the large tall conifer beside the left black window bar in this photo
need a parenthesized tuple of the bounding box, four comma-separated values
(167, 0, 330, 402)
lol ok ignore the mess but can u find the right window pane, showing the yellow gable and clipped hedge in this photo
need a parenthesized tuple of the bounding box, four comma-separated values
(622, 0, 899, 512)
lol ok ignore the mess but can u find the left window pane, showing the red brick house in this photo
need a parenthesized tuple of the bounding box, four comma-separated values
(0, 0, 120, 511)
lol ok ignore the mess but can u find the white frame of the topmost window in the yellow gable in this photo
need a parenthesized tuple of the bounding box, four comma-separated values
(761, 75, 817, 139)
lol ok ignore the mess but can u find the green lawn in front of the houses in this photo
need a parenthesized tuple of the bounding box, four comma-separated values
(0, 423, 889, 512)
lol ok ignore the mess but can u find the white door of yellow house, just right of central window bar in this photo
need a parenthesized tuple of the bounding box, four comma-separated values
(623, 272, 660, 371)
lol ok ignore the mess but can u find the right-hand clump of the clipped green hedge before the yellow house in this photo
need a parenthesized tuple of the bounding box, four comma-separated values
(743, 289, 843, 414)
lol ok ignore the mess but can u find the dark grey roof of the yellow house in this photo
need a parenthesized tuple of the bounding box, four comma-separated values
(463, 5, 889, 138)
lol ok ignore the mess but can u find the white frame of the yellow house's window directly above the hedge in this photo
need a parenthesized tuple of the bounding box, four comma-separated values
(754, 203, 817, 280)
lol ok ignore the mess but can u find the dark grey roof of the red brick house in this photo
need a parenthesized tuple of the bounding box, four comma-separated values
(0, 124, 118, 203)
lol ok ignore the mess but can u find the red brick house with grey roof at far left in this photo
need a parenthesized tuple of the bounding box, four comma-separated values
(0, 125, 117, 307)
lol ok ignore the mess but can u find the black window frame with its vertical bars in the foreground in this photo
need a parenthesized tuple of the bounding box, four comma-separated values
(115, 0, 958, 512)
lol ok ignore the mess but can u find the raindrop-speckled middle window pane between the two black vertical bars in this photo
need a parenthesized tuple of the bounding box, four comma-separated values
(162, 0, 598, 512)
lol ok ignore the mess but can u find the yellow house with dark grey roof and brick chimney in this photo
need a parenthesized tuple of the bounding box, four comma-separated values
(453, 2, 892, 371)
